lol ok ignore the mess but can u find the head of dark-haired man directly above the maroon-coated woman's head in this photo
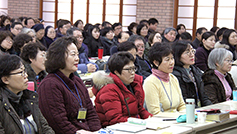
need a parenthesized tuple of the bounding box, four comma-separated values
(56, 19, 72, 38)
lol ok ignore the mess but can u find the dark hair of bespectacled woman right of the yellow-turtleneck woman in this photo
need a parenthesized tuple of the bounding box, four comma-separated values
(172, 40, 192, 67)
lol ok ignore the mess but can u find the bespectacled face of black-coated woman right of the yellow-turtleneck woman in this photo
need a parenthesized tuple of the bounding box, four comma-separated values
(180, 45, 196, 68)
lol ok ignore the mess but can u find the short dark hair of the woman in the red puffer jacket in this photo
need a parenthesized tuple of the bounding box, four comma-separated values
(108, 52, 135, 74)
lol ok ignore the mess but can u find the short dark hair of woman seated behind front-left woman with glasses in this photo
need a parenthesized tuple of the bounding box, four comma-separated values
(20, 42, 47, 63)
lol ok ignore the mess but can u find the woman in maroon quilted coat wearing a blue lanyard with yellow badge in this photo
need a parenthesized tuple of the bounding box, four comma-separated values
(37, 37, 101, 134)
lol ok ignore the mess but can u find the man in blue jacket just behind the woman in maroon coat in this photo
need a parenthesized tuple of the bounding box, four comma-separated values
(67, 27, 99, 73)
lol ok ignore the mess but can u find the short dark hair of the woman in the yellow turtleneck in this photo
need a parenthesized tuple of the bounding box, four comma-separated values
(148, 42, 173, 69)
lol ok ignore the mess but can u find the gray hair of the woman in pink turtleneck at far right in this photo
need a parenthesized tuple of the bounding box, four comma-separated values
(208, 48, 233, 69)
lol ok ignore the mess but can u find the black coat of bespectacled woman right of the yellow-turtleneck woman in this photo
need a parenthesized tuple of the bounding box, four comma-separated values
(173, 65, 212, 107)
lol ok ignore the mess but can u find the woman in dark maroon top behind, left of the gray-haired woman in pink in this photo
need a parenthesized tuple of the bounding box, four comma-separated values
(195, 32, 216, 71)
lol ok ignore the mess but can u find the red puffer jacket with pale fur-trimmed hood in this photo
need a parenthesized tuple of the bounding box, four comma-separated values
(92, 72, 152, 127)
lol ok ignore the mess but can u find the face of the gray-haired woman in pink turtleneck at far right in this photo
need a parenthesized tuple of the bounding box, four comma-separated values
(217, 56, 232, 74)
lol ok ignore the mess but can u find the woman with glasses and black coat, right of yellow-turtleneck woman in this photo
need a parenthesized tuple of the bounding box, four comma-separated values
(172, 41, 212, 107)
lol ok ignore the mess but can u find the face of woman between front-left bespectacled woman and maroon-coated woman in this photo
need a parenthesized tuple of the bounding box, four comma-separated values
(30, 50, 46, 74)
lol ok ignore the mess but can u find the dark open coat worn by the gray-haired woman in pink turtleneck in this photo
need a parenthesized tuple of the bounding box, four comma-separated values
(202, 69, 235, 104)
